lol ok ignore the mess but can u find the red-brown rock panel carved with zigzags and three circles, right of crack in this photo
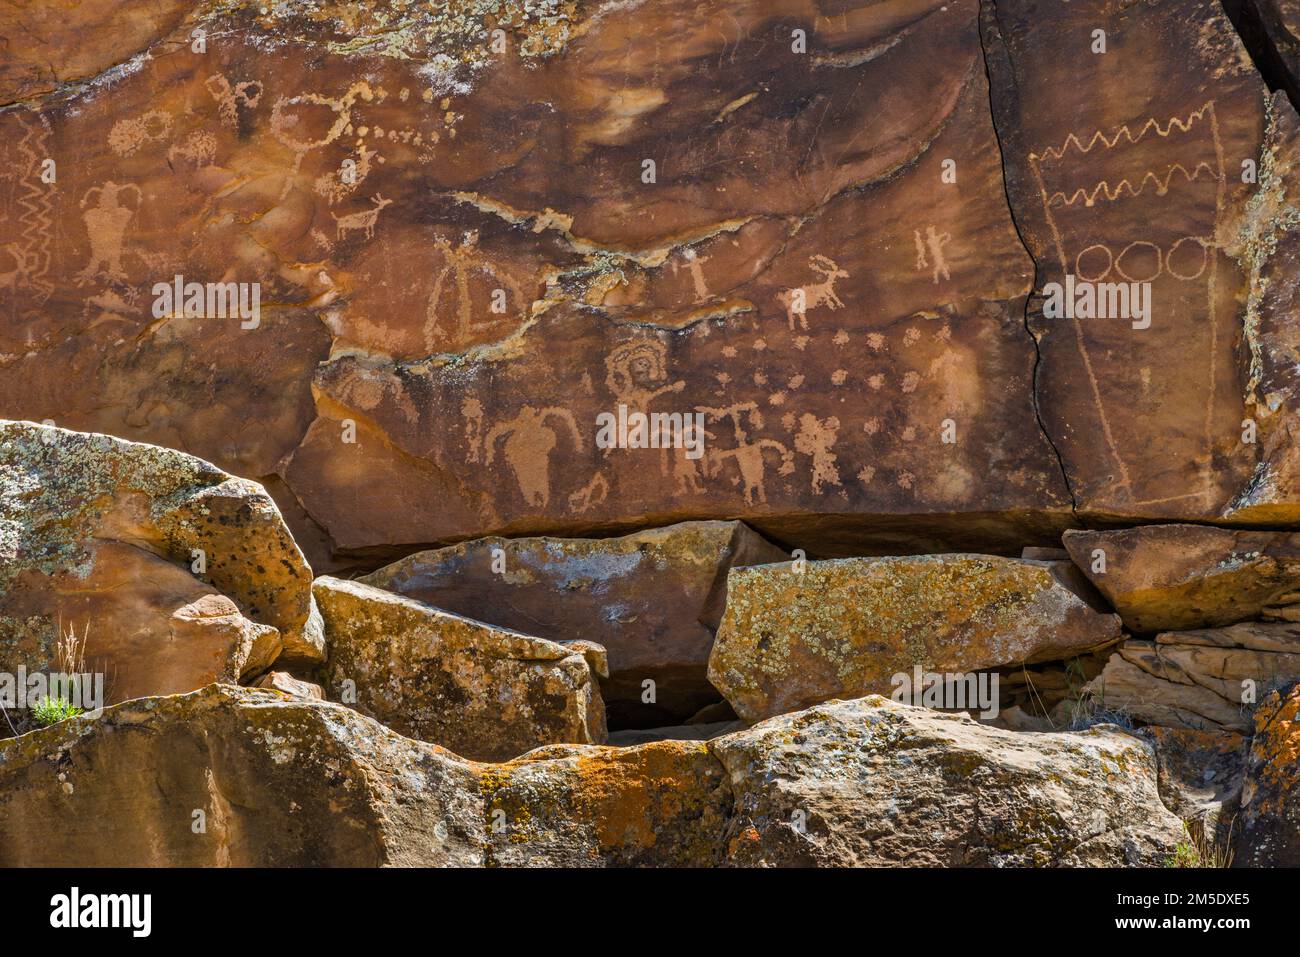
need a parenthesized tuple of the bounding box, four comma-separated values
(982, 0, 1279, 519)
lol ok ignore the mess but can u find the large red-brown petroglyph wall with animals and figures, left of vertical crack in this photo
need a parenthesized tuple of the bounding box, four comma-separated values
(0, 0, 1069, 567)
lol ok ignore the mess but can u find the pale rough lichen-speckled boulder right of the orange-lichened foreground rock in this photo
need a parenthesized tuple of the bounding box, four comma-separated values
(711, 696, 1183, 867)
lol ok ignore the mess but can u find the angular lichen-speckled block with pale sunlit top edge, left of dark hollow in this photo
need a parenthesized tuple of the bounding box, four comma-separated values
(315, 577, 605, 761)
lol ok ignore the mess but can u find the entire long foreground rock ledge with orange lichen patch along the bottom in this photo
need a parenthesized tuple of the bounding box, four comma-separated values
(0, 685, 1183, 867)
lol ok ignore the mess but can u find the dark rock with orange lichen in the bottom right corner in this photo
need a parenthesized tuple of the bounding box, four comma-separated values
(1235, 688, 1300, 867)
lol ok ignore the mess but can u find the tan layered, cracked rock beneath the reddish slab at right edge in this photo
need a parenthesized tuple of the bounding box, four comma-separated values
(1087, 623, 1300, 731)
